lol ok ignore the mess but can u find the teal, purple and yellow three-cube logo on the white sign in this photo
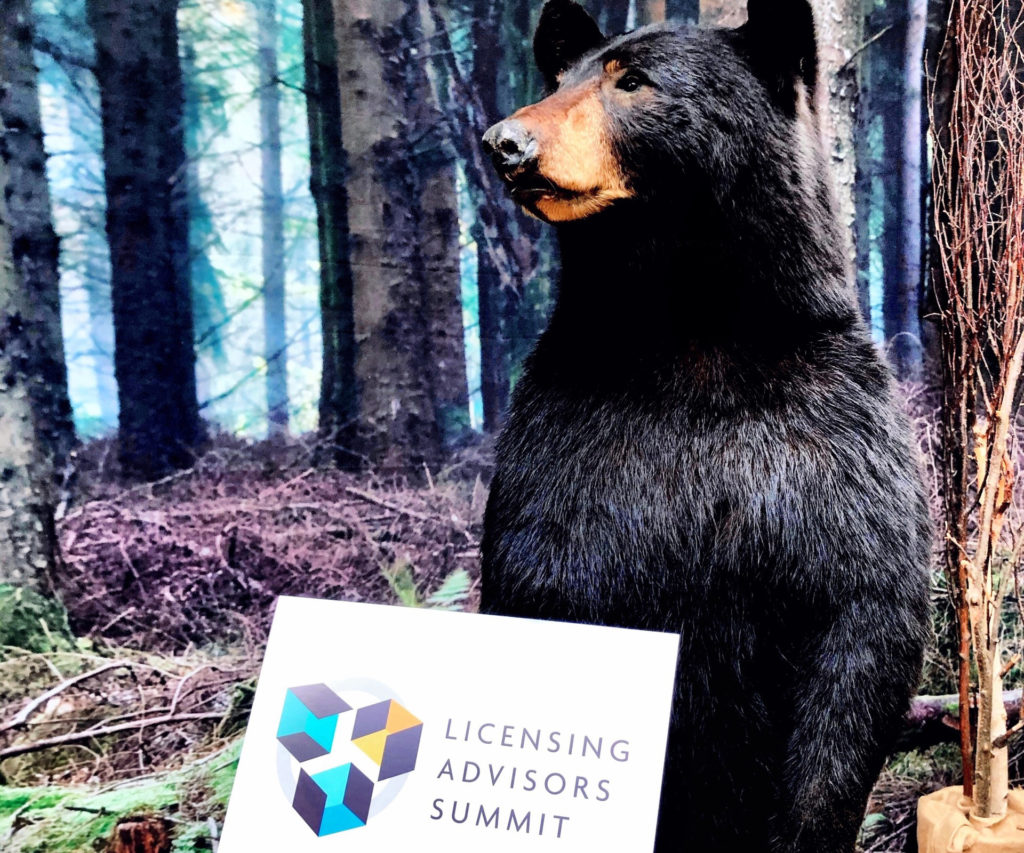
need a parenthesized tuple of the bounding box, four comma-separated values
(278, 684, 423, 838)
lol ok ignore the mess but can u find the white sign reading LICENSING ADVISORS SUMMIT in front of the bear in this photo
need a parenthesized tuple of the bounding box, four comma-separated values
(219, 598, 678, 853)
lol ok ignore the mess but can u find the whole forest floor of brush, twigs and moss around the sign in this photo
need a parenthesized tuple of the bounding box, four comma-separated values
(0, 421, 1007, 853)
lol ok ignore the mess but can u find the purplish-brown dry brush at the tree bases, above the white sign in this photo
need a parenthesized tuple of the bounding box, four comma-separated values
(60, 438, 486, 652)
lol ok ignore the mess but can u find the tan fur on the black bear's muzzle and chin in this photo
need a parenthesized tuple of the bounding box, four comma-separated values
(505, 80, 632, 222)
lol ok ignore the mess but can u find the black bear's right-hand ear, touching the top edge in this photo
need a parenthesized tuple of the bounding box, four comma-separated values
(743, 0, 818, 101)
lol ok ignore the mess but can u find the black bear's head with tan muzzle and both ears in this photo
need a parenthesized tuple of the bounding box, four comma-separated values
(483, 0, 817, 222)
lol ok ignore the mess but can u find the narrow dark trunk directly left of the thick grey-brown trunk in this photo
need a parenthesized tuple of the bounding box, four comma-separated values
(302, 0, 359, 468)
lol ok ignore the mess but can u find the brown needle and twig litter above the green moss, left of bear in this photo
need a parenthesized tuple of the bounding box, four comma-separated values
(0, 437, 487, 785)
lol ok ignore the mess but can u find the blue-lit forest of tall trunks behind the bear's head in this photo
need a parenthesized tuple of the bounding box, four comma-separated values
(0, 0, 945, 478)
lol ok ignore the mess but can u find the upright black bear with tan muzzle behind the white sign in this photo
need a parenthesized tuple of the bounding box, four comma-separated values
(481, 0, 930, 853)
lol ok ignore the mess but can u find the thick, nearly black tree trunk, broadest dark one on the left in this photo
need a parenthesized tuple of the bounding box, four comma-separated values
(87, 0, 203, 479)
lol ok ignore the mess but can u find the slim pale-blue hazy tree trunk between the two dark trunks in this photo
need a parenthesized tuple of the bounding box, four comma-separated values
(256, 0, 288, 437)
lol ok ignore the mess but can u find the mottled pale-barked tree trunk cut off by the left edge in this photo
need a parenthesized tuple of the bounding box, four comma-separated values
(0, 116, 56, 594)
